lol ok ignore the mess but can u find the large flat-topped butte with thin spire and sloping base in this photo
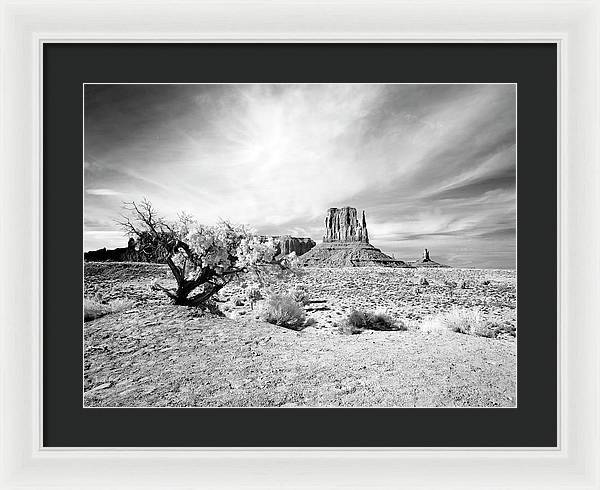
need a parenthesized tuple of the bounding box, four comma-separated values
(301, 207, 410, 267)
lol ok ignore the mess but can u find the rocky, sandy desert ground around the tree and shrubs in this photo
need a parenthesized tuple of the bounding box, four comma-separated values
(83, 262, 517, 407)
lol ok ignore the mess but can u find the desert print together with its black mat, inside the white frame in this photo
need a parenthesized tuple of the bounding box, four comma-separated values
(44, 43, 557, 447)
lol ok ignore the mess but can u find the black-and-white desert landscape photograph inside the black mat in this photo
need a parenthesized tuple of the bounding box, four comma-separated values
(82, 83, 516, 409)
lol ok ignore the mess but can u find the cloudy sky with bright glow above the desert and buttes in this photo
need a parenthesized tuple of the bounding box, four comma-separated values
(84, 84, 516, 269)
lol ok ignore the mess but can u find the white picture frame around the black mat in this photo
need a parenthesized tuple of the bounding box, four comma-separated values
(0, 0, 600, 489)
